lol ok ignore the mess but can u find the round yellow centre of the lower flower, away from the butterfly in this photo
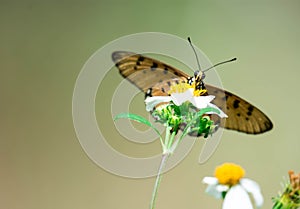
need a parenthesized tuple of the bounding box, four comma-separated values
(215, 163, 245, 186)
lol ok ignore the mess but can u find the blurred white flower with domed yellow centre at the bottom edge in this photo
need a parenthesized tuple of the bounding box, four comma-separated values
(202, 163, 264, 209)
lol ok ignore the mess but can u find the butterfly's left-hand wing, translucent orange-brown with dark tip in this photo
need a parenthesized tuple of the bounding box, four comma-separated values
(112, 51, 188, 96)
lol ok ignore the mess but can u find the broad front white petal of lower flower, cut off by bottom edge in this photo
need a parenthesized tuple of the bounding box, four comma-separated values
(222, 185, 253, 209)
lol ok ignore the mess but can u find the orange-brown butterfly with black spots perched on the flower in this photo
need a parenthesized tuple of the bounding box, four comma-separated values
(112, 51, 273, 134)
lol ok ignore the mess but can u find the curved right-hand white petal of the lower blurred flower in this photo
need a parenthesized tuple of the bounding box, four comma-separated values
(240, 178, 264, 208)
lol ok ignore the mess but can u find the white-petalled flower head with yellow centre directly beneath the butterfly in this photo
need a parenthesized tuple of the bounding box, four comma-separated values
(145, 84, 227, 118)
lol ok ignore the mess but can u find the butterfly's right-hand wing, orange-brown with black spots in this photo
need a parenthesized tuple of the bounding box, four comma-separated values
(205, 85, 273, 134)
